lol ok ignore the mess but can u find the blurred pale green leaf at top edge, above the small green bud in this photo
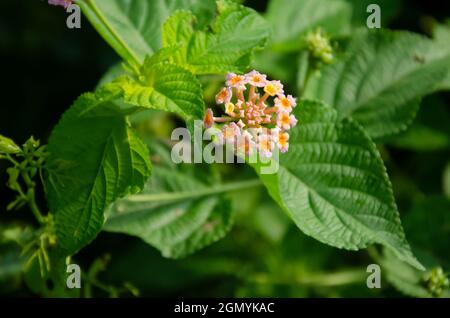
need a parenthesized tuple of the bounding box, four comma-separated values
(267, 0, 352, 51)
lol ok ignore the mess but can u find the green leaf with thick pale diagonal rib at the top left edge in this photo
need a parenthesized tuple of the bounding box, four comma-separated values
(77, 0, 214, 65)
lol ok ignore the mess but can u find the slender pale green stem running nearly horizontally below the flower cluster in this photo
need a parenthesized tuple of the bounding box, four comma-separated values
(127, 179, 262, 202)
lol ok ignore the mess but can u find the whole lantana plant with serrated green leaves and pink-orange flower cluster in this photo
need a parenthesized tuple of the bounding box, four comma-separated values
(0, 0, 450, 296)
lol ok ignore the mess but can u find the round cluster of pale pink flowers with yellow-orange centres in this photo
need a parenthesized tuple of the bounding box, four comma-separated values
(204, 70, 297, 157)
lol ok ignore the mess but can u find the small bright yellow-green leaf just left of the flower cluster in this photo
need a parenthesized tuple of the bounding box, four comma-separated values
(114, 58, 204, 120)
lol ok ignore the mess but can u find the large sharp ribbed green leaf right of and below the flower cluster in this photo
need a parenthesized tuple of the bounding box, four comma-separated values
(251, 101, 422, 268)
